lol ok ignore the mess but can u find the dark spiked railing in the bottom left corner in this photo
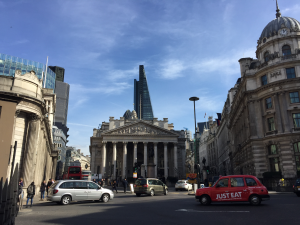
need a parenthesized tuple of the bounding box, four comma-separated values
(0, 164, 19, 225)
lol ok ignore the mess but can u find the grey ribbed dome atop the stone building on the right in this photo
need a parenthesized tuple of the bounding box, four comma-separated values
(259, 15, 300, 40)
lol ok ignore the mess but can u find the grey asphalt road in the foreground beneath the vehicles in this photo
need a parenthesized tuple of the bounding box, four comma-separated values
(16, 191, 300, 225)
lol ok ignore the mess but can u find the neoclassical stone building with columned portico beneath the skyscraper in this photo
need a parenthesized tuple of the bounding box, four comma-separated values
(90, 111, 186, 179)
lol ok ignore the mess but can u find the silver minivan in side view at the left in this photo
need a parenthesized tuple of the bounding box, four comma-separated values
(47, 180, 114, 205)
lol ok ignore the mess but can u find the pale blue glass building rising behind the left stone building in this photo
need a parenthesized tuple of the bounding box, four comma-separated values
(0, 53, 56, 91)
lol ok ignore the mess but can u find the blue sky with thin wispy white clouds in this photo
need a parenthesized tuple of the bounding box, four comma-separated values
(0, 0, 300, 154)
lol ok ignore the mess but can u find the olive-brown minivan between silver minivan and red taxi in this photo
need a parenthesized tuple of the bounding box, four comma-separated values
(134, 178, 168, 197)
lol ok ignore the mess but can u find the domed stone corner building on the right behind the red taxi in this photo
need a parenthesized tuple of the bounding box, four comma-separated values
(227, 6, 300, 186)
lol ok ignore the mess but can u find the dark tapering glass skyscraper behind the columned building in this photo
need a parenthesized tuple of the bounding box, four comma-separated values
(134, 65, 154, 120)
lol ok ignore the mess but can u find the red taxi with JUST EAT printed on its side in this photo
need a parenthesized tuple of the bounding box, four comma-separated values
(195, 175, 270, 205)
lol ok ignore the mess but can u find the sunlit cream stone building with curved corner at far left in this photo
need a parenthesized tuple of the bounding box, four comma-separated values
(0, 70, 58, 192)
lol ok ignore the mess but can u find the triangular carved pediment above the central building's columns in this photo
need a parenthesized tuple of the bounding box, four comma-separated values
(101, 121, 178, 137)
